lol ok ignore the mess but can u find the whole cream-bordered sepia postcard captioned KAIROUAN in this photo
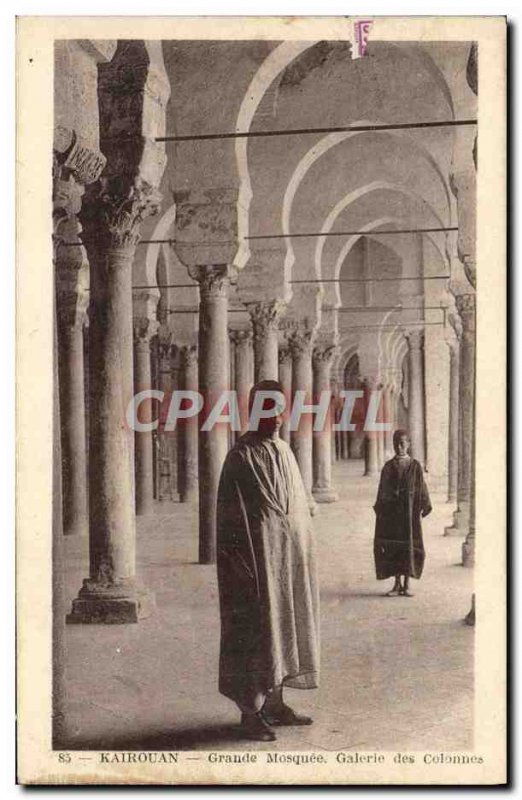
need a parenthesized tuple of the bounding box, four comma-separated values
(17, 14, 507, 785)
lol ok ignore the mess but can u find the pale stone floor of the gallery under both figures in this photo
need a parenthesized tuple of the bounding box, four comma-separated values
(61, 462, 473, 751)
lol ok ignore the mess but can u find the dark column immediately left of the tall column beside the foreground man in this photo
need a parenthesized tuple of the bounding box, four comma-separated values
(177, 346, 198, 503)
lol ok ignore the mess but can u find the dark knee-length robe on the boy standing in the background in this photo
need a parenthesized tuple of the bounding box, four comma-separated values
(373, 458, 431, 580)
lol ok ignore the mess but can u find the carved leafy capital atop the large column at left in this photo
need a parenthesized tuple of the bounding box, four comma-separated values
(80, 179, 161, 250)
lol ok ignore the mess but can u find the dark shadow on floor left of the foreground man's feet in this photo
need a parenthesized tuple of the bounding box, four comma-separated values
(64, 725, 242, 750)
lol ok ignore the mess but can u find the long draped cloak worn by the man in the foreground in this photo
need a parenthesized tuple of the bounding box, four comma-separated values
(217, 433, 319, 706)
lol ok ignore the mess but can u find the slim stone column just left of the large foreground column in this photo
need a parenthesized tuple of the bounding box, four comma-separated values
(57, 293, 88, 535)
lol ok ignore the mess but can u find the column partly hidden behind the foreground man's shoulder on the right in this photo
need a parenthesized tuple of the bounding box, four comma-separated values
(288, 329, 315, 511)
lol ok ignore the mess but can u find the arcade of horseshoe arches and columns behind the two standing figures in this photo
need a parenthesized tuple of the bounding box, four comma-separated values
(53, 40, 477, 744)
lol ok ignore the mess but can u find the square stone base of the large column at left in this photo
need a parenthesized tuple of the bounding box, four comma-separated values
(66, 580, 155, 625)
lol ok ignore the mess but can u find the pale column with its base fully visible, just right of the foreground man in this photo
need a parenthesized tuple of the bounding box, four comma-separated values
(312, 345, 339, 503)
